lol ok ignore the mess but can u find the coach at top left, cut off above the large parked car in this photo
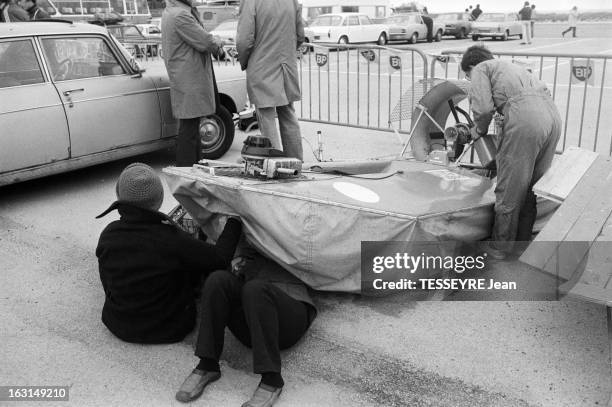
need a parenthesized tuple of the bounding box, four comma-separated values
(36, 0, 151, 24)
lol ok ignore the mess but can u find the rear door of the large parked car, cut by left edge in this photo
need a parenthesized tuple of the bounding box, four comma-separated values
(0, 38, 70, 173)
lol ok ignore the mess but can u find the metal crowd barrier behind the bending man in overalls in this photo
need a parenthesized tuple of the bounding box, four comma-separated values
(430, 50, 612, 155)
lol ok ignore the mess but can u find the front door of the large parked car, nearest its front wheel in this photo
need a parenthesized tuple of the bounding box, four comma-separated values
(40, 35, 162, 157)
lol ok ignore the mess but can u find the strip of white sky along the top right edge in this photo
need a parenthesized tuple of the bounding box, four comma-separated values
(391, 0, 612, 13)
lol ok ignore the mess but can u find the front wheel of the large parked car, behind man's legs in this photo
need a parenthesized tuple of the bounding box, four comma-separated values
(199, 106, 234, 160)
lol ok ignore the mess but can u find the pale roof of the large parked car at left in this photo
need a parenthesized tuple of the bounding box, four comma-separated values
(0, 21, 106, 38)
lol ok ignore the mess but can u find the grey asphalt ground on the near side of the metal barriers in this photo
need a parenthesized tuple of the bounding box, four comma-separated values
(0, 122, 612, 407)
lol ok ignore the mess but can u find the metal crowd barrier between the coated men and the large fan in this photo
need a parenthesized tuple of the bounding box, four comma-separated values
(295, 44, 428, 132)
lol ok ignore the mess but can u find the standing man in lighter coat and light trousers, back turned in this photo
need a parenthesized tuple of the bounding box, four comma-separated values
(236, 0, 304, 160)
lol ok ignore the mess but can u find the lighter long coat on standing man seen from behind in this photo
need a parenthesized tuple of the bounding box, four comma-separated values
(236, 0, 304, 108)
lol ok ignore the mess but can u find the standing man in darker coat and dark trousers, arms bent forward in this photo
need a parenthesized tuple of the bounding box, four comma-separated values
(162, 0, 223, 167)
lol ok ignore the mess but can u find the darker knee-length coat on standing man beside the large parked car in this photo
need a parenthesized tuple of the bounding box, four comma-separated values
(162, 0, 217, 119)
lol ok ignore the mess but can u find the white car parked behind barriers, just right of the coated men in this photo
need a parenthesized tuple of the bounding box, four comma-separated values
(308, 13, 389, 45)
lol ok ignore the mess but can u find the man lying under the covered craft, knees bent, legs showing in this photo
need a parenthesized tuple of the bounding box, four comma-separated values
(176, 243, 316, 407)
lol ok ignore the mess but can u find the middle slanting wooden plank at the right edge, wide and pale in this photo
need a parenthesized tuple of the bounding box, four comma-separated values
(519, 156, 612, 269)
